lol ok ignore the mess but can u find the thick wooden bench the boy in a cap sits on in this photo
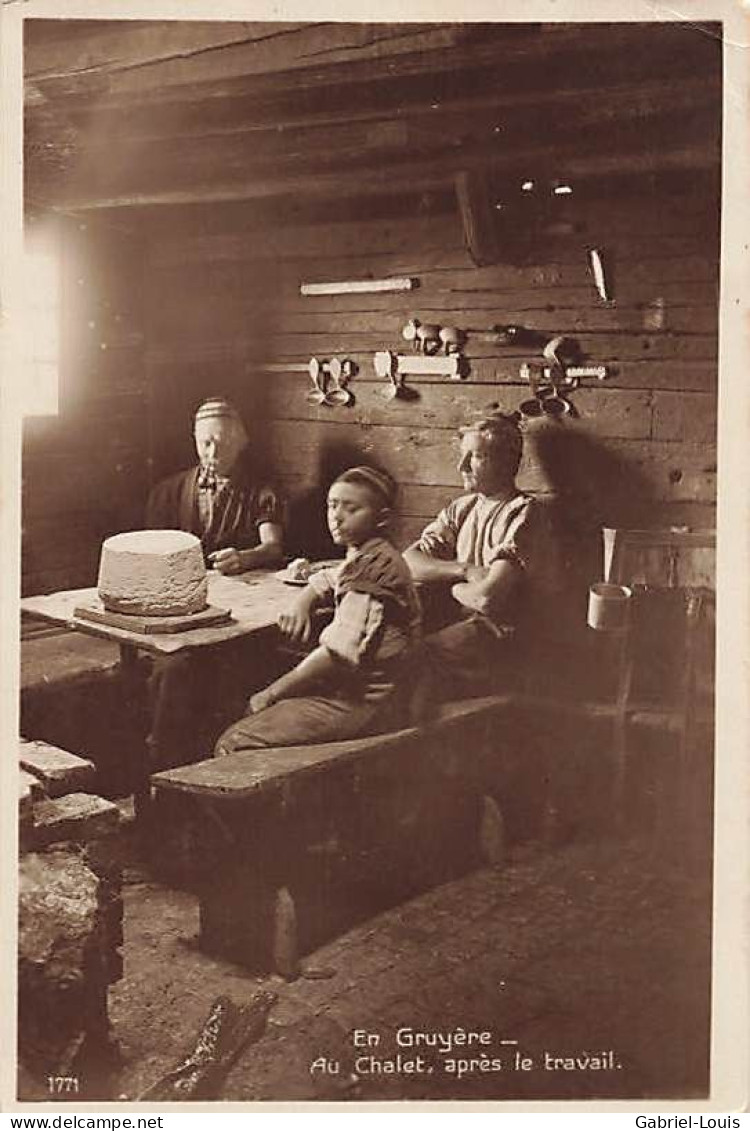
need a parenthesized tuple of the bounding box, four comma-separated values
(152, 696, 533, 973)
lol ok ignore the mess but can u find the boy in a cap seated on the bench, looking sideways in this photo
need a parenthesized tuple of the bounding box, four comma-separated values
(215, 467, 420, 756)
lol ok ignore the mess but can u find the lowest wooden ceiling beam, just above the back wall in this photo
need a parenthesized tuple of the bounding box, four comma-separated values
(27, 102, 718, 206)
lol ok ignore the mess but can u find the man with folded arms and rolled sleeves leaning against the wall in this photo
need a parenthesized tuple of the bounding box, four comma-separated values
(404, 412, 566, 713)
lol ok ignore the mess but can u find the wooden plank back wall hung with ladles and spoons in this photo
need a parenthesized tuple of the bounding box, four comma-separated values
(146, 183, 718, 563)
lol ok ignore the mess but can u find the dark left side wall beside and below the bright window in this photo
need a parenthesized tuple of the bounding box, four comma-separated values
(21, 219, 148, 594)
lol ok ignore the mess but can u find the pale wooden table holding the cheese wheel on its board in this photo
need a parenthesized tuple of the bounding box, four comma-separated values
(20, 570, 303, 817)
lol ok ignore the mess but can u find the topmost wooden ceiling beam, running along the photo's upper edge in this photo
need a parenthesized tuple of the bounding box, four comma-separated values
(24, 24, 721, 114)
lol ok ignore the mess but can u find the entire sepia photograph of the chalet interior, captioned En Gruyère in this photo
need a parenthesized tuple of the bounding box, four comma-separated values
(4, 5, 747, 1107)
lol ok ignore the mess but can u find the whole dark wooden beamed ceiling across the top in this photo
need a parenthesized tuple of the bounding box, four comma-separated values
(25, 19, 722, 221)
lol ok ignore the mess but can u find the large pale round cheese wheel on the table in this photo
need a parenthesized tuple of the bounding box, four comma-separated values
(98, 530, 208, 616)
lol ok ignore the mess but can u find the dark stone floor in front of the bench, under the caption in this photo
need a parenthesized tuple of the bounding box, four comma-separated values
(111, 828, 710, 1102)
